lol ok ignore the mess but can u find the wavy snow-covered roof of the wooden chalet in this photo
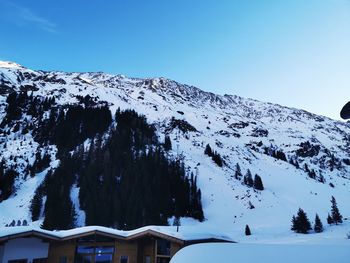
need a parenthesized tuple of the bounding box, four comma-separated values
(0, 226, 233, 243)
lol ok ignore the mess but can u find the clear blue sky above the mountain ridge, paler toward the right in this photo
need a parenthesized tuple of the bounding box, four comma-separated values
(0, 0, 350, 119)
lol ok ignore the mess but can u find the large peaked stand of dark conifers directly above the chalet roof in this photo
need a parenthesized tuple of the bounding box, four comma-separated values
(37, 110, 204, 229)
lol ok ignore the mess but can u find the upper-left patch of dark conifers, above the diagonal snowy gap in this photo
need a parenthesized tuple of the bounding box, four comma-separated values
(0, 92, 112, 153)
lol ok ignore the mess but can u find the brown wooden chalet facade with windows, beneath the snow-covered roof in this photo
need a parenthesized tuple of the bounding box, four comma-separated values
(0, 229, 232, 263)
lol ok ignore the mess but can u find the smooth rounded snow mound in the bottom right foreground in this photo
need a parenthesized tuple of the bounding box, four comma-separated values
(170, 242, 350, 263)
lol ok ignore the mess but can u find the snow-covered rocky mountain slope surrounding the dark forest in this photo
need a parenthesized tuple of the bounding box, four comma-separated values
(0, 62, 350, 243)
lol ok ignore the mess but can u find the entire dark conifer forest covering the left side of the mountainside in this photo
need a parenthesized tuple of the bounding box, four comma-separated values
(0, 92, 204, 229)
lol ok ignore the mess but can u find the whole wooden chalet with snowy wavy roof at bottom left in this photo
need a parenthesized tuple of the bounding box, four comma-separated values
(0, 226, 232, 263)
